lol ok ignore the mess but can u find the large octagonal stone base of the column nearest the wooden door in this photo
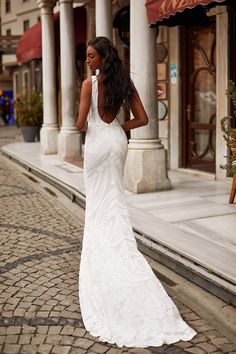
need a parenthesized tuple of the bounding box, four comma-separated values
(124, 140, 171, 193)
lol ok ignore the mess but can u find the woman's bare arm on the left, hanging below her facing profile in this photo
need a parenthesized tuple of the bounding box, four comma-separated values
(76, 78, 92, 131)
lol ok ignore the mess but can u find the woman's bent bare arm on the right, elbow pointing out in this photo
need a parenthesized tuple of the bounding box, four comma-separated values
(122, 89, 148, 132)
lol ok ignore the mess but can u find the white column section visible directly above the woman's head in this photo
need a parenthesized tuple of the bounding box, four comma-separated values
(96, 0, 112, 40)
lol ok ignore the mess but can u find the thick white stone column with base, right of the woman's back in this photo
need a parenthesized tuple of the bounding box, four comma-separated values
(125, 0, 170, 193)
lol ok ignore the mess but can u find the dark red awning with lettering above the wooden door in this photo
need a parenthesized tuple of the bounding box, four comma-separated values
(145, 0, 225, 25)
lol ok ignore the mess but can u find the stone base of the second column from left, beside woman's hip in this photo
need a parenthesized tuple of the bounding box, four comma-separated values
(58, 128, 82, 161)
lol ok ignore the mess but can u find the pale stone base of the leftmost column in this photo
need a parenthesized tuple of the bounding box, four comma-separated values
(40, 124, 59, 155)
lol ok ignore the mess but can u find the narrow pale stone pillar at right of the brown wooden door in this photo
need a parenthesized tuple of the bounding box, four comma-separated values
(216, 6, 229, 180)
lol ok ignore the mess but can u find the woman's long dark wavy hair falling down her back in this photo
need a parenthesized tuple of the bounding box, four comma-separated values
(88, 37, 134, 116)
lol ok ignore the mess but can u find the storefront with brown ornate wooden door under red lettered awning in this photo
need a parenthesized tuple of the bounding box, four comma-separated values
(146, 0, 232, 179)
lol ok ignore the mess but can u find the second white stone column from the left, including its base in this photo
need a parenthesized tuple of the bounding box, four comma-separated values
(58, 0, 81, 161)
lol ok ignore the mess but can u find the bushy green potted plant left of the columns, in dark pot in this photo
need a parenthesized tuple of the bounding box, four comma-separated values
(15, 90, 43, 142)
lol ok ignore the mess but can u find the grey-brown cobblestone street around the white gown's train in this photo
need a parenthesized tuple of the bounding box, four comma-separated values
(0, 148, 236, 354)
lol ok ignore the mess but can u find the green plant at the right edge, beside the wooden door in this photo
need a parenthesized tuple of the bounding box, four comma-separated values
(221, 81, 236, 173)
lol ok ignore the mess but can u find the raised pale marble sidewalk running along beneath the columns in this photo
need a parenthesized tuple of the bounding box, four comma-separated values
(2, 143, 236, 305)
